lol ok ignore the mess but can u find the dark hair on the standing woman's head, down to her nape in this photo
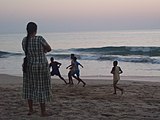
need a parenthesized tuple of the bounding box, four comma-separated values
(26, 22, 37, 40)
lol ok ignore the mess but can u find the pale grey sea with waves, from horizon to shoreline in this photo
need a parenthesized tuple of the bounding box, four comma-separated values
(0, 30, 160, 77)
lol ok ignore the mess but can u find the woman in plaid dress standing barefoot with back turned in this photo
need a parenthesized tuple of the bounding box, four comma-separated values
(22, 22, 51, 116)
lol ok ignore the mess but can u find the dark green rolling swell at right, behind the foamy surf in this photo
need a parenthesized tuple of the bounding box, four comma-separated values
(72, 46, 160, 56)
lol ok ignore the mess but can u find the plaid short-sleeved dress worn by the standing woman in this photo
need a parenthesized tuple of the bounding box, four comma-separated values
(22, 36, 51, 103)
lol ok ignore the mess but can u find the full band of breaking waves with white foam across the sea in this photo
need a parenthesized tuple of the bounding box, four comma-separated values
(0, 46, 160, 64)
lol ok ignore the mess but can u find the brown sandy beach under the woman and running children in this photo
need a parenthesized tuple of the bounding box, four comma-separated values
(0, 74, 160, 120)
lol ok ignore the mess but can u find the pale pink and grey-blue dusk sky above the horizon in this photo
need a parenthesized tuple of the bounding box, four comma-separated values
(0, 0, 160, 33)
